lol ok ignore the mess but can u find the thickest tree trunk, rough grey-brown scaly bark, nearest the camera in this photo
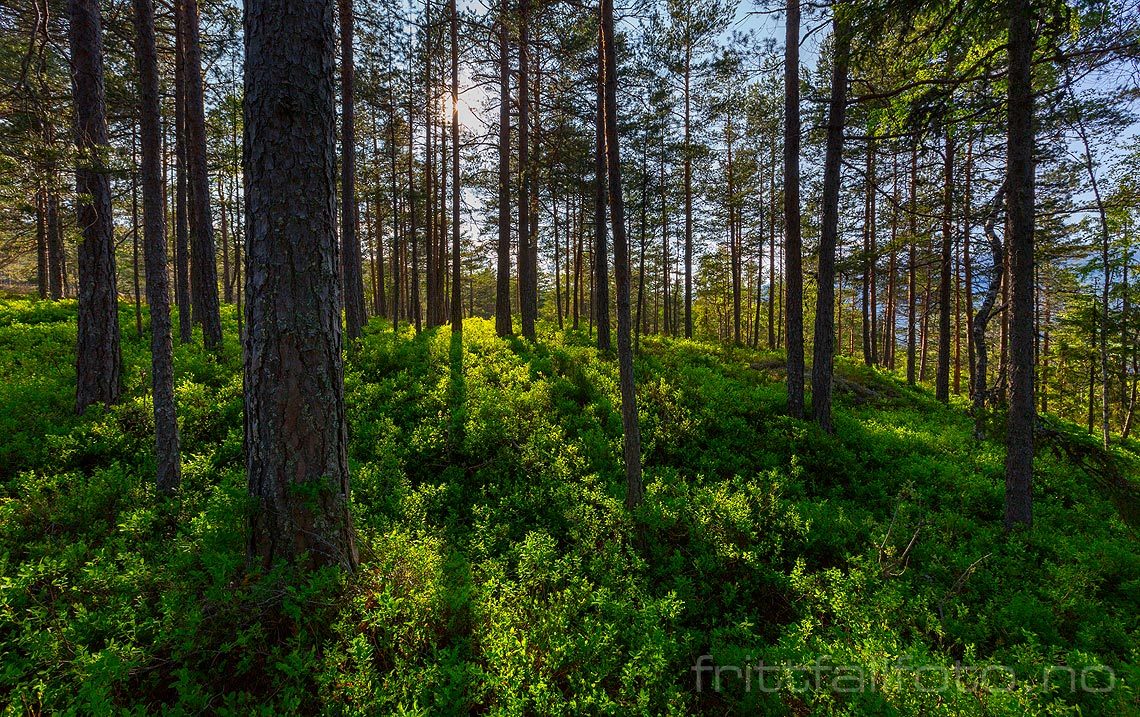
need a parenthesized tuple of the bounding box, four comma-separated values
(244, 0, 358, 569)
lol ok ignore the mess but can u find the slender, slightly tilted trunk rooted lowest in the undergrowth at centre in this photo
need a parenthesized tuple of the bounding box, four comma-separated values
(597, 0, 645, 510)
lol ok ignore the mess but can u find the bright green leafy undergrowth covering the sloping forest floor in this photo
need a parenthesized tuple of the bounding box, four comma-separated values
(0, 299, 1140, 716)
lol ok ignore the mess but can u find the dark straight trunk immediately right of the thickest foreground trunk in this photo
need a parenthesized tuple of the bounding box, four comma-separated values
(340, 0, 367, 341)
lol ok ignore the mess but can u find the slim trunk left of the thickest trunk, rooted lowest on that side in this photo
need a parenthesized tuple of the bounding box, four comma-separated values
(135, 0, 181, 492)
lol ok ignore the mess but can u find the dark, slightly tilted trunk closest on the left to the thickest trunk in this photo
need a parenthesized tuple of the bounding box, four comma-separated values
(177, 0, 221, 351)
